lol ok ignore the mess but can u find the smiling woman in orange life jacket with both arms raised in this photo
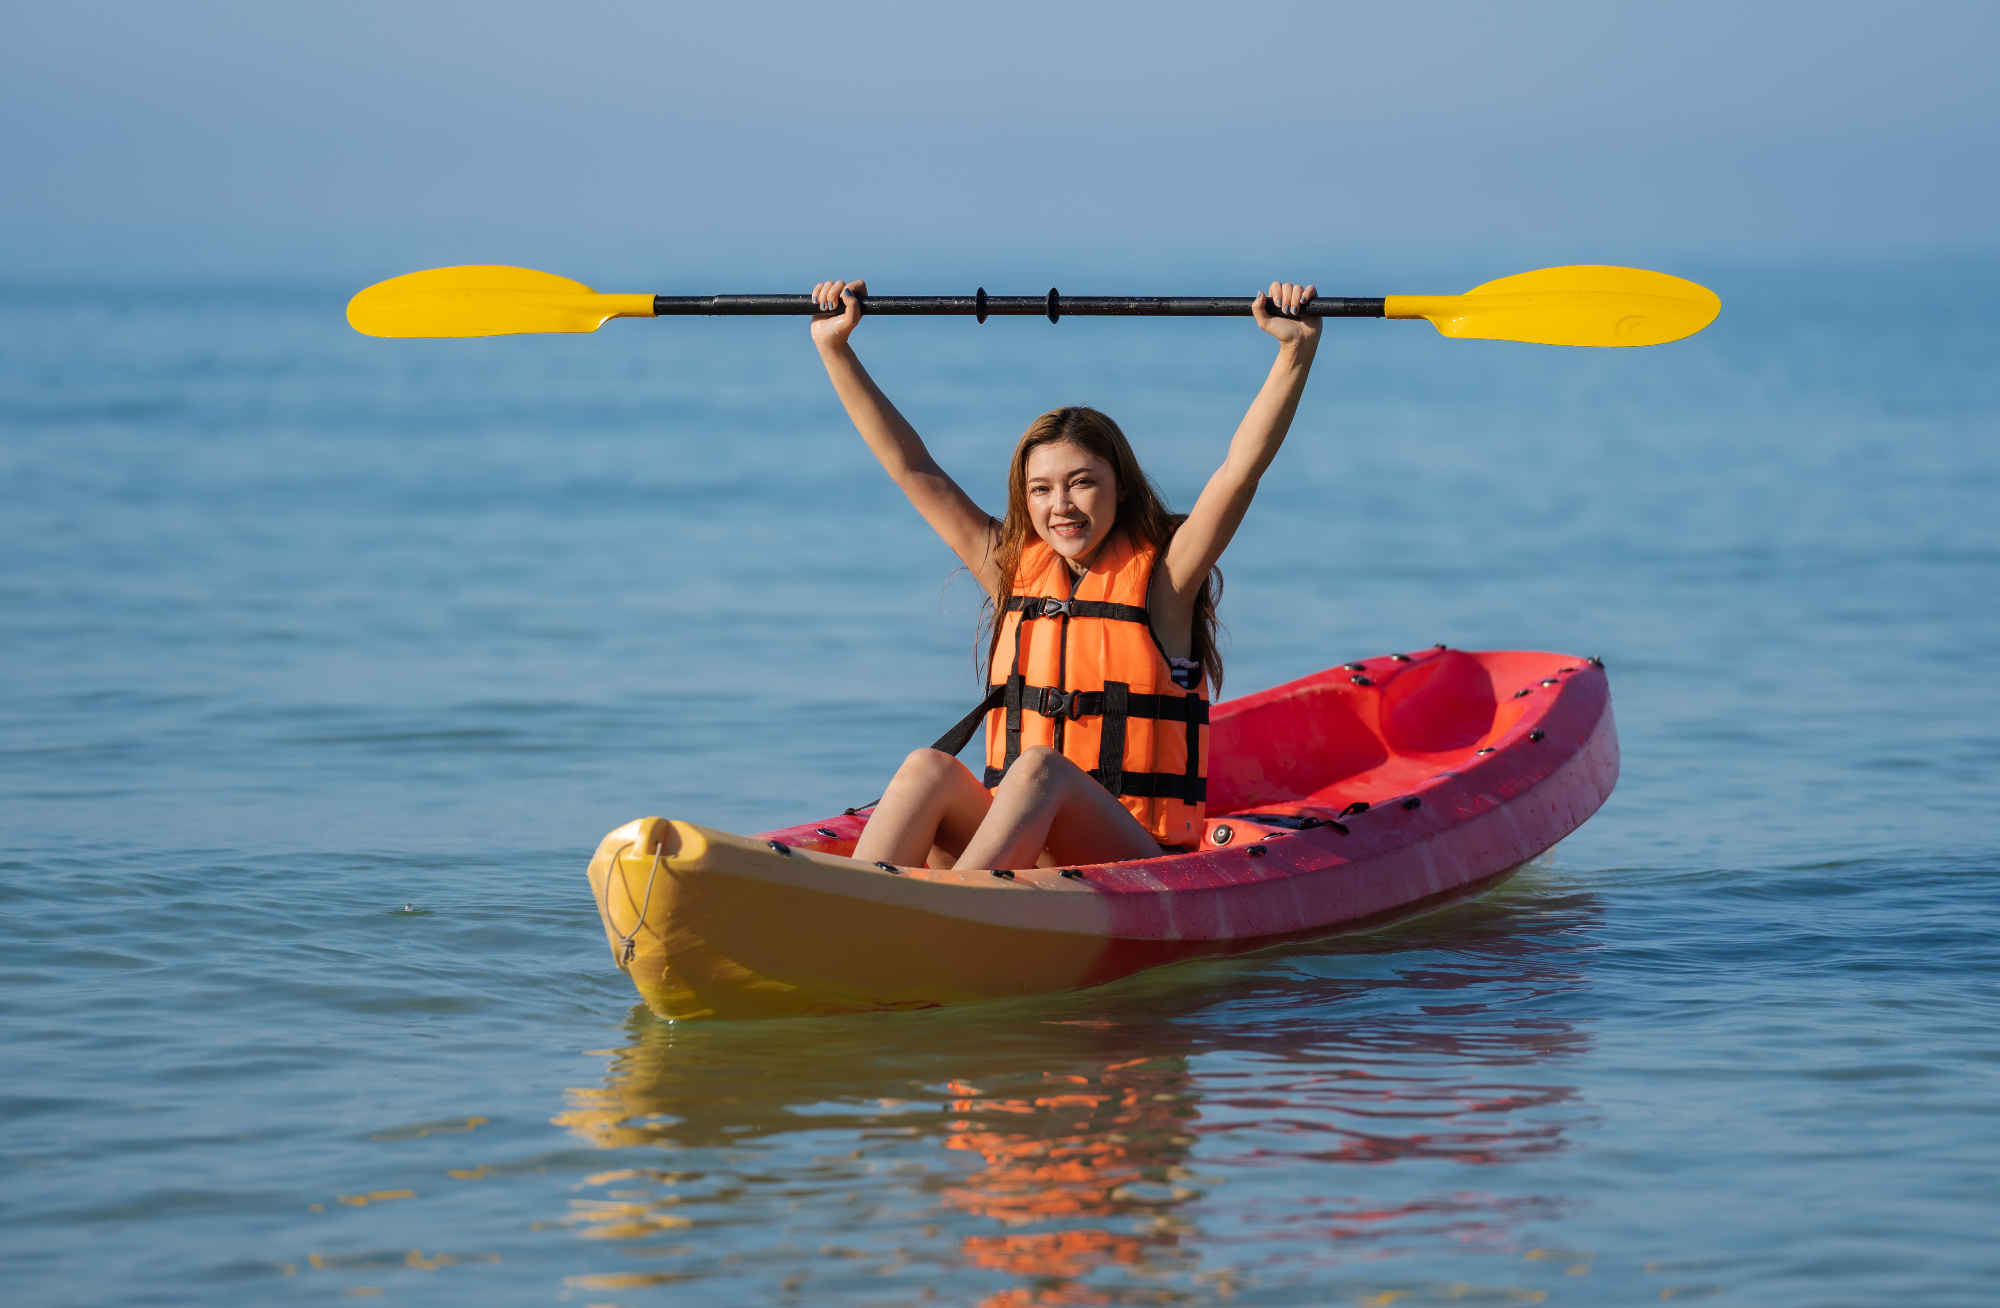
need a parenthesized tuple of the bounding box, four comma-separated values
(812, 282, 1320, 868)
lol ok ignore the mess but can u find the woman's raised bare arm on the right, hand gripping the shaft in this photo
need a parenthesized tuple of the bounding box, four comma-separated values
(1152, 282, 1320, 630)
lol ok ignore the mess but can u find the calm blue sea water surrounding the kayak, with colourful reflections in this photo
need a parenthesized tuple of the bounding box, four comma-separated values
(0, 260, 2000, 1308)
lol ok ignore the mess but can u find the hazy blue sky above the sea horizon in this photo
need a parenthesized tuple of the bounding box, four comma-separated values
(0, 0, 2000, 282)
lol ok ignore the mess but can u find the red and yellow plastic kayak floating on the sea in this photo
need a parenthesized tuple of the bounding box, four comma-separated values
(588, 646, 1618, 1020)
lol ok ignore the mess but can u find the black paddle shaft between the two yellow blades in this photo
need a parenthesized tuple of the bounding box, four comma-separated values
(652, 288, 1382, 322)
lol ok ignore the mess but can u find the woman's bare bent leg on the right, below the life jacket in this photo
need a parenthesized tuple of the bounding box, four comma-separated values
(948, 744, 1160, 868)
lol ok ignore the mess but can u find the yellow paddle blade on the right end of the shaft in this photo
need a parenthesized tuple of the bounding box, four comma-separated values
(1382, 264, 1722, 346)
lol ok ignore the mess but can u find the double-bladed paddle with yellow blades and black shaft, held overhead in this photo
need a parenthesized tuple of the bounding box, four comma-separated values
(348, 264, 1722, 346)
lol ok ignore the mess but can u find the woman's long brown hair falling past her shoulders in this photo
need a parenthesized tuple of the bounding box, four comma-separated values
(980, 404, 1222, 698)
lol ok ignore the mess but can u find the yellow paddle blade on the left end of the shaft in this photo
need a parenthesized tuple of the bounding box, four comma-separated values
(348, 264, 652, 336)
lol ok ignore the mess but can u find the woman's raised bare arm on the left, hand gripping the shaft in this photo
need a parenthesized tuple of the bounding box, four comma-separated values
(812, 282, 1000, 592)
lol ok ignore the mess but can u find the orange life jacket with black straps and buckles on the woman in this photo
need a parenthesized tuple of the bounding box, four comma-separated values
(976, 530, 1208, 846)
